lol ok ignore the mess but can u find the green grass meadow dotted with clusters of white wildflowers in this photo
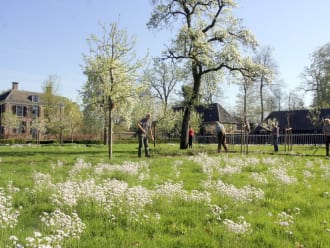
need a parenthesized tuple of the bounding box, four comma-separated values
(0, 144, 330, 248)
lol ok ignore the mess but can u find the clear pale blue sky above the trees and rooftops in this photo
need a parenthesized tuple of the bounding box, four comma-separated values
(0, 0, 330, 105)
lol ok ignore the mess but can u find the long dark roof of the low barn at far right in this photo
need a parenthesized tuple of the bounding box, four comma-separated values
(265, 109, 330, 131)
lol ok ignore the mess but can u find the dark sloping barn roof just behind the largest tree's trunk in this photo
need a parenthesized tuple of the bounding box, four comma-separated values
(173, 103, 238, 124)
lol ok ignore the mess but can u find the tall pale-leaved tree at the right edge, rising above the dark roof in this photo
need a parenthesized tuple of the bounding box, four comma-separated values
(302, 42, 330, 108)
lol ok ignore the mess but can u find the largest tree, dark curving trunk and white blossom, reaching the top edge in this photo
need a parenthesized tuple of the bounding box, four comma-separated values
(147, 0, 257, 149)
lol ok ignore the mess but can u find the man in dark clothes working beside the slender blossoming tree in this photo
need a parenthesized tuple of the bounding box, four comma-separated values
(137, 113, 154, 157)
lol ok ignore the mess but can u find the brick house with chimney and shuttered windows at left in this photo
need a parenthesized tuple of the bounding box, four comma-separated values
(0, 82, 43, 139)
